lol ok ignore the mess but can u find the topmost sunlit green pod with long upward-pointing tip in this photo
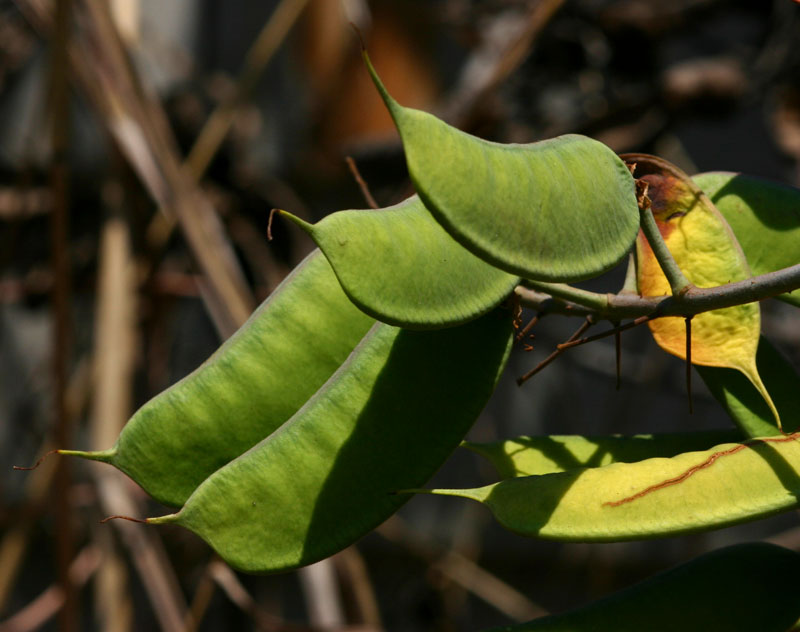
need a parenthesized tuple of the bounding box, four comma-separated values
(364, 53, 639, 281)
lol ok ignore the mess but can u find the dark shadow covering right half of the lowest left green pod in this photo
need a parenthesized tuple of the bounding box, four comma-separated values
(303, 311, 511, 563)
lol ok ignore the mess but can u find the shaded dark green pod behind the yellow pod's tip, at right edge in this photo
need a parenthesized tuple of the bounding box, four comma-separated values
(697, 336, 800, 437)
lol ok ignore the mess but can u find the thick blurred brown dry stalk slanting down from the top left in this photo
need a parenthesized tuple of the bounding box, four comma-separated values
(17, 0, 255, 338)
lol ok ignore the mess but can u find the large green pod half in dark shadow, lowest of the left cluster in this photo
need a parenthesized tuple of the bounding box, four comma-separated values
(148, 311, 512, 573)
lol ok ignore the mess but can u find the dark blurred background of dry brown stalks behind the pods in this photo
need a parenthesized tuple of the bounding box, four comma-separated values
(0, 0, 800, 632)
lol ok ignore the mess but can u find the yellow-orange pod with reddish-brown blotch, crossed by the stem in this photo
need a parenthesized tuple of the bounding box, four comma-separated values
(623, 154, 780, 423)
